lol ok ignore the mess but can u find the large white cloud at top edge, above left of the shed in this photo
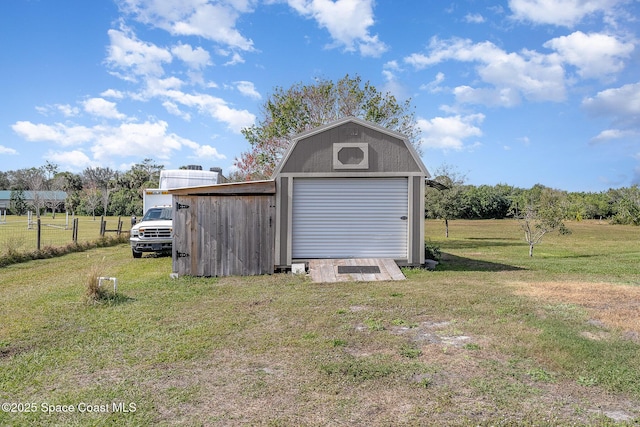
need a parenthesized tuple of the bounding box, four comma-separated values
(120, 0, 254, 51)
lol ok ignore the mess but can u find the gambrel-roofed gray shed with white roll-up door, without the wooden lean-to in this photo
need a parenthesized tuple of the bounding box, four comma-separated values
(274, 117, 429, 267)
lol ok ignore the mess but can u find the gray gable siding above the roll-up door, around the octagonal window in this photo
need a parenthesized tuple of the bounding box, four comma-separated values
(280, 123, 421, 175)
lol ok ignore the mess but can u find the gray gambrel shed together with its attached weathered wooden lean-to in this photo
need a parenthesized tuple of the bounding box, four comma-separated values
(169, 117, 429, 276)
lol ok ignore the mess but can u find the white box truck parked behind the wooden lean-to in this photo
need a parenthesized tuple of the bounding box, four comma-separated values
(129, 168, 224, 258)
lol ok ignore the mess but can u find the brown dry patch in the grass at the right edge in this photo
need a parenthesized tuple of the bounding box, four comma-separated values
(515, 282, 640, 341)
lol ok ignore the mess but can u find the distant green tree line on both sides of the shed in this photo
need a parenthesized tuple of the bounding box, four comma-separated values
(0, 159, 640, 225)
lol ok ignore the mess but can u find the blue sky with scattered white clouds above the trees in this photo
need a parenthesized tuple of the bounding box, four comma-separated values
(0, 0, 640, 191)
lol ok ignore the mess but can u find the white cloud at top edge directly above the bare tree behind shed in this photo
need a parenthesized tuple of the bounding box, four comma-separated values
(288, 0, 388, 57)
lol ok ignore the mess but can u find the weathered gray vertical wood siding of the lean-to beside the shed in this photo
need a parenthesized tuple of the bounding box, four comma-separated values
(173, 195, 275, 277)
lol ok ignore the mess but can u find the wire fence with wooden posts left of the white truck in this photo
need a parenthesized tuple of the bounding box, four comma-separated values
(0, 210, 129, 256)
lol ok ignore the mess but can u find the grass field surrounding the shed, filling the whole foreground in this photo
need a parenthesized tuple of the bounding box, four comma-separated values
(0, 221, 640, 426)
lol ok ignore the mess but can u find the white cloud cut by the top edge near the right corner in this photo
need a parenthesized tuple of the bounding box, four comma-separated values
(509, 0, 622, 27)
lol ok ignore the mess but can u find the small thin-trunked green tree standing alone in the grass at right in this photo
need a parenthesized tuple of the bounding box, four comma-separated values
(517, 186, 571, 257)
